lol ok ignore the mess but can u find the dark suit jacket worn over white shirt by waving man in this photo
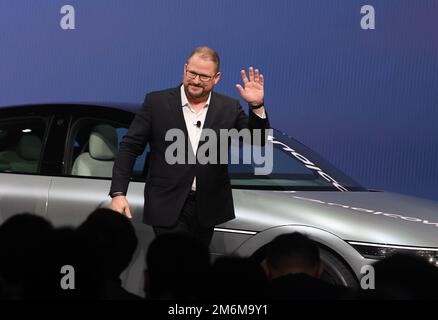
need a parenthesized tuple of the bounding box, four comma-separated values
(110, 86, 269, 226)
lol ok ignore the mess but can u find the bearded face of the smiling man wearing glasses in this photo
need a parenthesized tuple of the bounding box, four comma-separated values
(183, 54, 221, 99)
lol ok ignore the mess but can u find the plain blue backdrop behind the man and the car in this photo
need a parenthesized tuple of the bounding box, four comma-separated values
(0, 0, 438, 200)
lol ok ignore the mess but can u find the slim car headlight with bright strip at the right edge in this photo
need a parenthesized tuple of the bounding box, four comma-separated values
(348, 241, 438, 267)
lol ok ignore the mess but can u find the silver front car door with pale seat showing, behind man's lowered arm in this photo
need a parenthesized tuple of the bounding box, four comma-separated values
(47, 112, 154, 295)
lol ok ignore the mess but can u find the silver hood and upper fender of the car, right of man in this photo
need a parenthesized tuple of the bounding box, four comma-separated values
(221, 190, 438, 247)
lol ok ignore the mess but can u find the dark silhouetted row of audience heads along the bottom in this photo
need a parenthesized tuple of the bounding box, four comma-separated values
(0, 212, 438, 301)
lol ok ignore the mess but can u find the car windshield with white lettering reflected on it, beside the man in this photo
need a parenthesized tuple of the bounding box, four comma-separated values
(228, 130, 366, 191)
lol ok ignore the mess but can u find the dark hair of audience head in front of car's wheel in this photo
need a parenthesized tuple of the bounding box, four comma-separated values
(266, 232, 321, 268)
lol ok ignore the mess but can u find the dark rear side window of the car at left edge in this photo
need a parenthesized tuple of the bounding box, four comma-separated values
(0, 118, 46, 173)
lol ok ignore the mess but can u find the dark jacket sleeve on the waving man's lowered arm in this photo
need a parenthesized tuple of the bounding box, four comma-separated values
(109, 95, 152, 194)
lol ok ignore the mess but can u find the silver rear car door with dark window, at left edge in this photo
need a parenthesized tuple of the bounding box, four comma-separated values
(0, 107, 51, 223)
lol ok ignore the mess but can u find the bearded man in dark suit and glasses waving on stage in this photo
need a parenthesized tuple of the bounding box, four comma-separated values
(110, 47, 269, 245)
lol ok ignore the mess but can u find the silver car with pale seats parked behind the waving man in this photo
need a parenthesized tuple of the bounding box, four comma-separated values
(0, 103, 438, 295)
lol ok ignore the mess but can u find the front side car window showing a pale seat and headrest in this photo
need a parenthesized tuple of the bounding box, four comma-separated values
(68, 119, 149, 181)
